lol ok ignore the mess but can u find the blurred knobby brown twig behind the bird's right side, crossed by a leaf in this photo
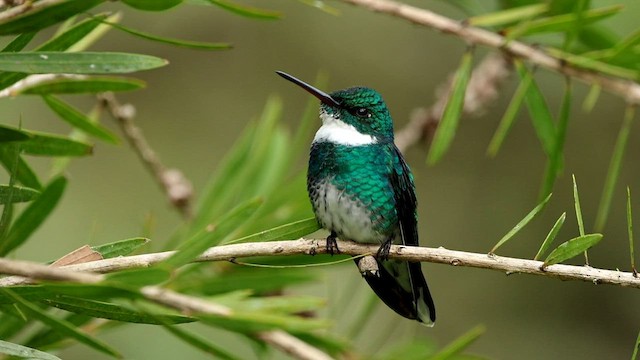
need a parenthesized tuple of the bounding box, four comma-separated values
(395, 52, 513, 152)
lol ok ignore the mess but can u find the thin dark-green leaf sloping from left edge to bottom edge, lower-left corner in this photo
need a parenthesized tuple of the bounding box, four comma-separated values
(0, 288, 122, 358)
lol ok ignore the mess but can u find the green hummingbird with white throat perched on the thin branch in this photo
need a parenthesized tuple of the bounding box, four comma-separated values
(276, 71, 436, 326)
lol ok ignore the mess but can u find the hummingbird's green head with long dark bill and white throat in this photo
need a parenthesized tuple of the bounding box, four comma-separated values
(277, 71, 393, 145)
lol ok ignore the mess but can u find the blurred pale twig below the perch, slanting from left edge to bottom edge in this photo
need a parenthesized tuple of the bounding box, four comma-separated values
(0, 258, 331, 360)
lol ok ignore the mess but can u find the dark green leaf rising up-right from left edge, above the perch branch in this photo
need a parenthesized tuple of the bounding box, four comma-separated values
(0, 176, 67, 256)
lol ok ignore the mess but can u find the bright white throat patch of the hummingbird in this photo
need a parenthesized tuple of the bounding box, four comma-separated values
(313, 111, 377, 146)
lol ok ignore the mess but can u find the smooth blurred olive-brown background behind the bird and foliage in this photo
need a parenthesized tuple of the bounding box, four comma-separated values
(0, 0, 640, 359)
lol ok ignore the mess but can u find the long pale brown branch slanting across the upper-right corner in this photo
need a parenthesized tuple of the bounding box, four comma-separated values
(342, 0, 640, 104)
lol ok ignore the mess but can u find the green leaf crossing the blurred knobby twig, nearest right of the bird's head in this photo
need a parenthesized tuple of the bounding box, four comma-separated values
(427, 50, 473, 165)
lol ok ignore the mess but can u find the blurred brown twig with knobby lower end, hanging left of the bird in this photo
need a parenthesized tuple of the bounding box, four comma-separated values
(98, 93, 193, 219)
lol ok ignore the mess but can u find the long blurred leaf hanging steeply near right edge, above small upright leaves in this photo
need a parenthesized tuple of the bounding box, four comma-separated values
(594, 105, 636, 232)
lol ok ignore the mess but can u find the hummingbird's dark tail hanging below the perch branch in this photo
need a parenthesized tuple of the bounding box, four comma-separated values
(354, 258, 436, 326)
